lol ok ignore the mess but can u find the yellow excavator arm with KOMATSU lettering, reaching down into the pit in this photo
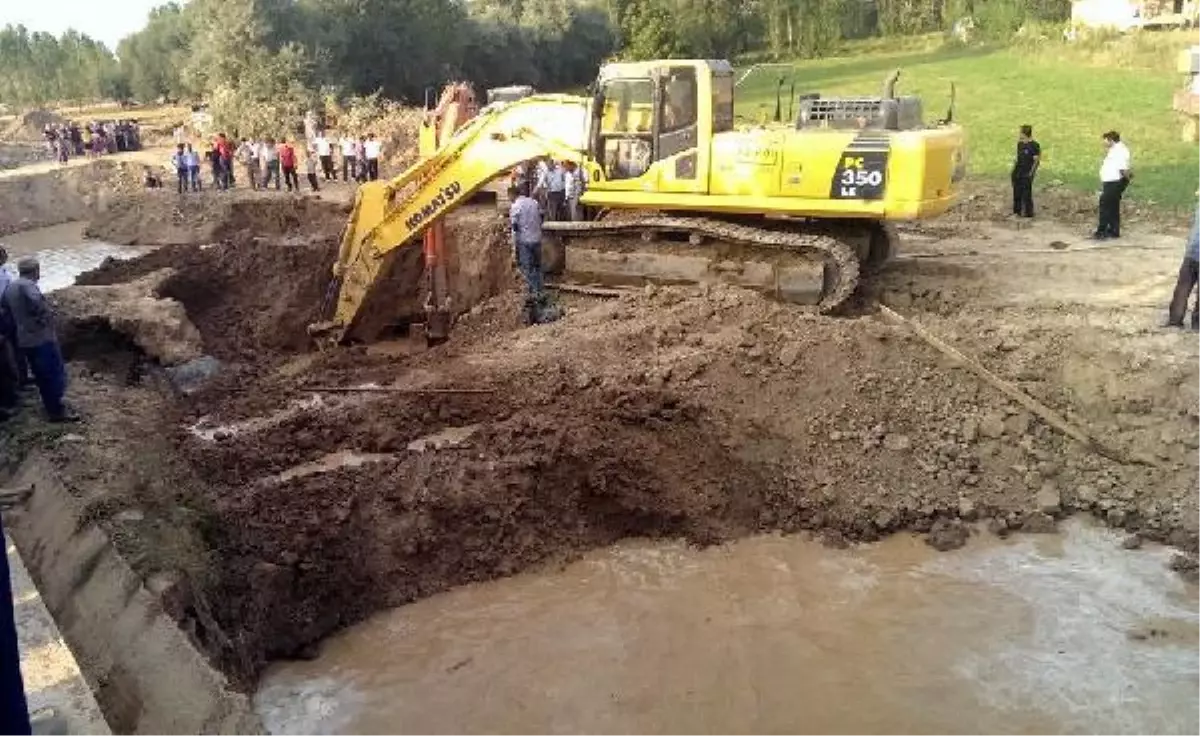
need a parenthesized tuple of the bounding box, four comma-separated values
(310, 95, 588, 342)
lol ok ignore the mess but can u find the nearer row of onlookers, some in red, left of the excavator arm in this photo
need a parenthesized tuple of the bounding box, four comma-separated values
(157, 133, 383, 195)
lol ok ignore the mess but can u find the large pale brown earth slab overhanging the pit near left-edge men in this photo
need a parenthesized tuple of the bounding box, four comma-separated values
(52, 269, 204, 365)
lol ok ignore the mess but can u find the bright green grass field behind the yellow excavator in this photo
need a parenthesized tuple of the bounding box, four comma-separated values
(737, 34, 1200, 213)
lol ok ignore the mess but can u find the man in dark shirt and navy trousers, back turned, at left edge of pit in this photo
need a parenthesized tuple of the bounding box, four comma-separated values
(4, 258, 79, 421)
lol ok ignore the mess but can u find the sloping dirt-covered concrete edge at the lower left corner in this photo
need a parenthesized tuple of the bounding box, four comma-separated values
(5, 453, 265, 736)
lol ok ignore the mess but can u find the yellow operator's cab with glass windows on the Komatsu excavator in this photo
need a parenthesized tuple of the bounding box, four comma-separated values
(588, 61, 733, 195)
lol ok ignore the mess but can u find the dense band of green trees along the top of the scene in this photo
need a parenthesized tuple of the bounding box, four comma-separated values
(0, 0, 1069, 121)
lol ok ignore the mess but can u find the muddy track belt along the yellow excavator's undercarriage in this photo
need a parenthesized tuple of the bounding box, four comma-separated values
(542, 213, 859, 313)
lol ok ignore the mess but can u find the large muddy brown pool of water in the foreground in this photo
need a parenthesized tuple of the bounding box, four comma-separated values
(256, 522, 1200, 736)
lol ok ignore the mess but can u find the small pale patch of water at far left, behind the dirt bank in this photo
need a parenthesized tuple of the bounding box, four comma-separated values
(0, 222, 154, 292)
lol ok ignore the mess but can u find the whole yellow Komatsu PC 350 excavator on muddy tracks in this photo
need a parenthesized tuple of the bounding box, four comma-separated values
(311, 60, 965, 341)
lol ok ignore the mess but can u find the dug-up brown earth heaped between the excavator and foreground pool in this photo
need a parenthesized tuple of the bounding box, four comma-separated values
(16, 190, 1196, 715)
